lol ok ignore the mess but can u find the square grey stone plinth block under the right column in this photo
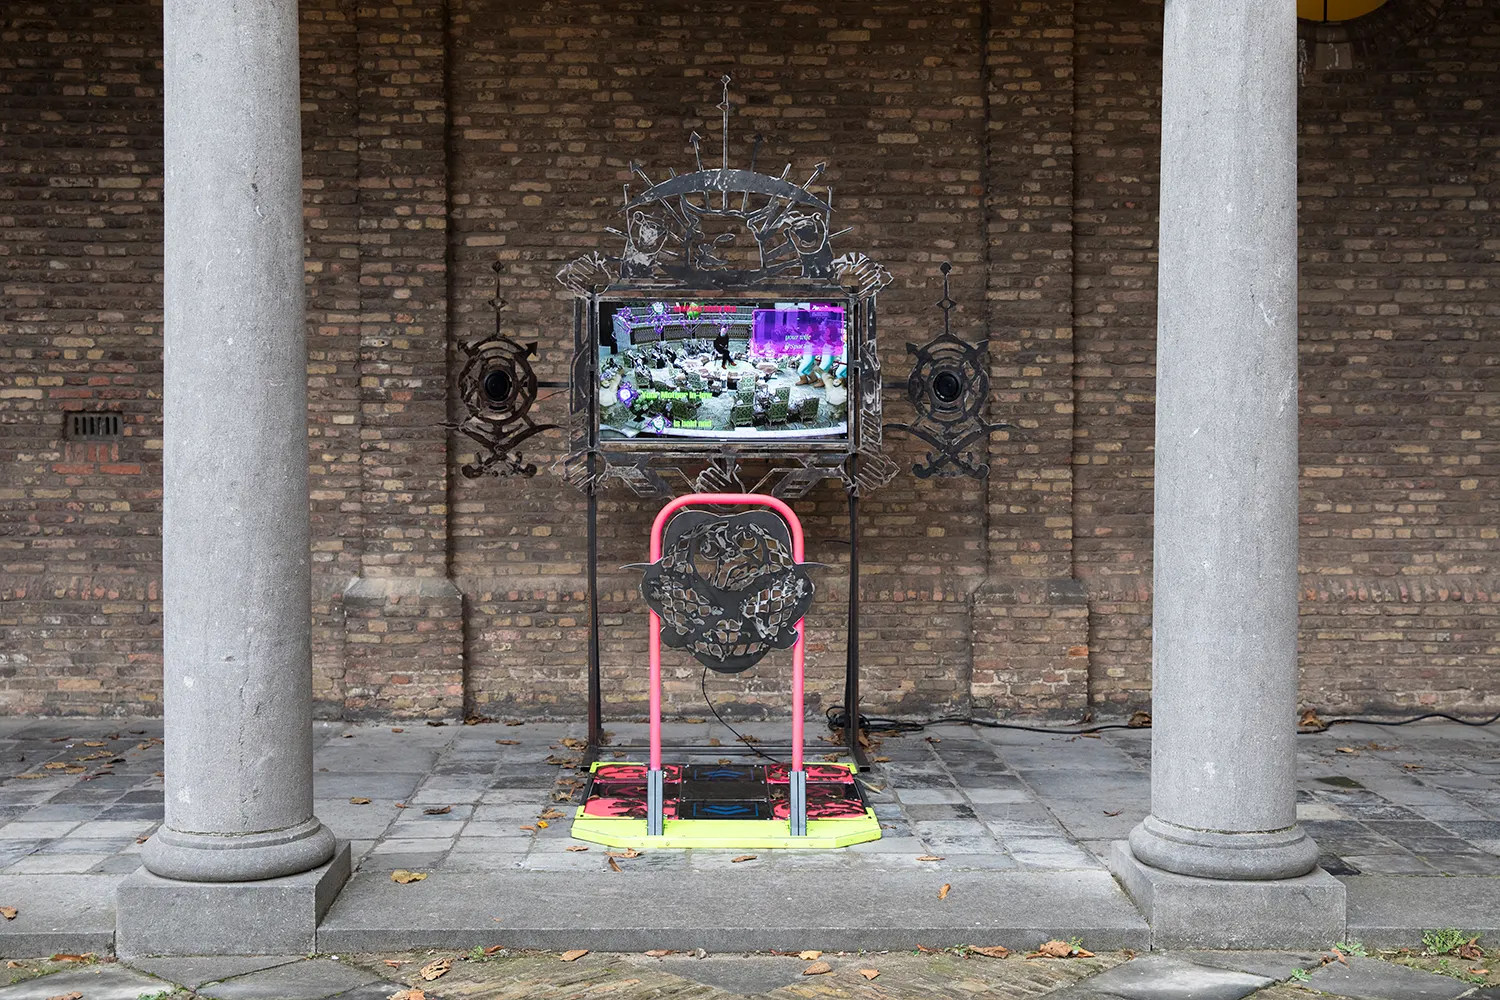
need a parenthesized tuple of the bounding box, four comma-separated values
(1109, 841, 1346, 951)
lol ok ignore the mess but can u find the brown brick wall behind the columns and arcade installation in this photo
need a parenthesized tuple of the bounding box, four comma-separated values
(0, 0, 1500, 717)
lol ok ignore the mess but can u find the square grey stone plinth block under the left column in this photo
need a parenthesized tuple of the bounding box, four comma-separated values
(114, 837, 351, 958)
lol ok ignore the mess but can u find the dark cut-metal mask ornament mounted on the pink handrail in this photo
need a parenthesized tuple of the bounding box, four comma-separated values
(641, 510, 813, 673)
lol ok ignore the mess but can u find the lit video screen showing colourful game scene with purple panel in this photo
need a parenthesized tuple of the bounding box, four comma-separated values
(599, 300, 849, 441)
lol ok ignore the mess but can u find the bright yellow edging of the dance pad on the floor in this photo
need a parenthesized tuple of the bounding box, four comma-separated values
(573, 760, 881, 850)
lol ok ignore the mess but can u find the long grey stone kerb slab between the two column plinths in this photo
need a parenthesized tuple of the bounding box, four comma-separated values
(318, 869, 1149, 952)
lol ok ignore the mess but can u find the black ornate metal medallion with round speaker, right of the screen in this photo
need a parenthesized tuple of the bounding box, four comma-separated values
(887, 261, 1011, 480)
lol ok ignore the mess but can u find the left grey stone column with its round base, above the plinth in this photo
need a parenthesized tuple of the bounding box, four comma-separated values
(146, 0, 335, 882)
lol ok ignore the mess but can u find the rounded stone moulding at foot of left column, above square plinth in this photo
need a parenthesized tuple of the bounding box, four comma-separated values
(143, 816, 336, 882)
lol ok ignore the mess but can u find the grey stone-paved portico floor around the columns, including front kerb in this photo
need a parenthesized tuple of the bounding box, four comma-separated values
(0, 720, 1500, 955)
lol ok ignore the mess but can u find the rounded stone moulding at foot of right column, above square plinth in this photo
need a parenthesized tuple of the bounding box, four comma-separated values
(1130, 816, 1317, 880)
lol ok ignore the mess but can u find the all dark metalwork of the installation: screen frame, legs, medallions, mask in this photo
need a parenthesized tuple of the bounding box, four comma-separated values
(459, 76, 1007, 763)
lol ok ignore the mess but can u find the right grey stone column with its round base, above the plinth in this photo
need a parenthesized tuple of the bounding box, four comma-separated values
(1130, 0, 1317, 880)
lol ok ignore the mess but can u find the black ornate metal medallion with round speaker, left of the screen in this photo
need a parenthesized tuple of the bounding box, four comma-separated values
(458, 261, 557, 480)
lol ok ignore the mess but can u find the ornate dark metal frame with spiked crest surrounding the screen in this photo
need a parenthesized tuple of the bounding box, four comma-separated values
(557, 76, 899, 498)
